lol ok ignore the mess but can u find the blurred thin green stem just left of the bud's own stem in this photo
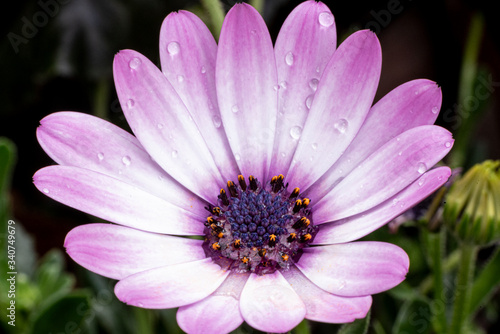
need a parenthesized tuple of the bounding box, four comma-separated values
(428, 229, 448, 333)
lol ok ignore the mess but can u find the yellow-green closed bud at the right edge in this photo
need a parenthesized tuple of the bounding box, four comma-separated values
(443, 160, 500, 246)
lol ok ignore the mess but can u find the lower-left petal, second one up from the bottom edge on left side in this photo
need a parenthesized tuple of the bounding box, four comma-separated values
(115, 258, 229, 309)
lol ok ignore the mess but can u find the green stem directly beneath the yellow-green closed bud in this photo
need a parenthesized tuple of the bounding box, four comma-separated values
(450, 243, 478, 334)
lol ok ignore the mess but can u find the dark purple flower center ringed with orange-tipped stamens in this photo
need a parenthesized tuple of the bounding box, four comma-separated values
(203, 174, 318, 275)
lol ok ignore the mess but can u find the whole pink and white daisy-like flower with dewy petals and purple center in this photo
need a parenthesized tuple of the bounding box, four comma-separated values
(34, 1, 453, 333)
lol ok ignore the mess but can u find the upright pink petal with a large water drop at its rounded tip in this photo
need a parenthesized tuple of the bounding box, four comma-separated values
(271, 1, 337, 175)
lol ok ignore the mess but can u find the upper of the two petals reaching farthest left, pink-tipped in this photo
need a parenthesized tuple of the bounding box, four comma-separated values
(36, 112, 206, 216)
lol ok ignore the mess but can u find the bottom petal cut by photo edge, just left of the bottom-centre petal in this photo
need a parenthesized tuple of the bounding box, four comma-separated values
(177, 272, 249, 334)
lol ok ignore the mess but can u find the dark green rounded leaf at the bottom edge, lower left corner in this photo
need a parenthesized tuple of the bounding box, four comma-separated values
(31, 291, 90, 334)
